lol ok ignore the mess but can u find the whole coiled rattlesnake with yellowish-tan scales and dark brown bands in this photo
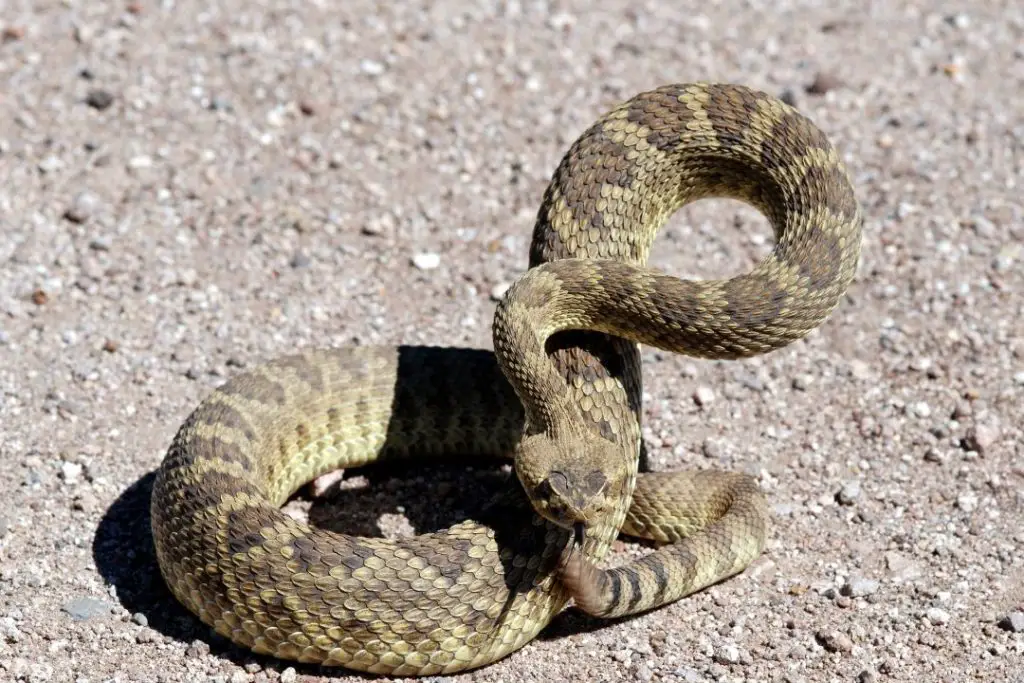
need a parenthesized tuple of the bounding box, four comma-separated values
(152, 84, 861, 675)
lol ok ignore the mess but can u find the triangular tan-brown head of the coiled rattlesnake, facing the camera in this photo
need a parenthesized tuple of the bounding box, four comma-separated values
(515, 433, 629, 528)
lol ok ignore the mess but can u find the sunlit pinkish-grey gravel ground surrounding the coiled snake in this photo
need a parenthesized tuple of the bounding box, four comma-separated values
(0, 0, 1024, 683)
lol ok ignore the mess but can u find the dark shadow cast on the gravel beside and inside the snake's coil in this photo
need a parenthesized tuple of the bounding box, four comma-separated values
(92, 456, 610, 678)
